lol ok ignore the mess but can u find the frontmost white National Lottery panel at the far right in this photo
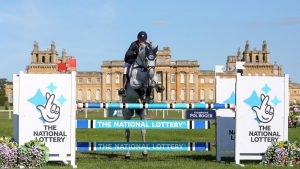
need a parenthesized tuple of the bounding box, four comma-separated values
(235, 75, 289, 161)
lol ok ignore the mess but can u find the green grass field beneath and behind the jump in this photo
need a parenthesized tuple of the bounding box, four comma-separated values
(0, 111, 300, 169)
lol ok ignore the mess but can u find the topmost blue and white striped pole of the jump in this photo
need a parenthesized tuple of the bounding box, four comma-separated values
(77, 103, 235, 109)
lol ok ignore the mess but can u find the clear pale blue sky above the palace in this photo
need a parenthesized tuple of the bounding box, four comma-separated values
(0, 0, 300, 83)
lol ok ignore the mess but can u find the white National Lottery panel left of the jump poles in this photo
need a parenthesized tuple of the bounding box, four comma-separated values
(14, 72, 76, 160)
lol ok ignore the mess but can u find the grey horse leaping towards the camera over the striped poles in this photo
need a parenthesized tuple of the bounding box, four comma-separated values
(122, 45, 164, 159)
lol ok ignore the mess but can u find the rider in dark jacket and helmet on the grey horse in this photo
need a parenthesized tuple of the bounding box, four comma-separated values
(119, 31, 150, 95)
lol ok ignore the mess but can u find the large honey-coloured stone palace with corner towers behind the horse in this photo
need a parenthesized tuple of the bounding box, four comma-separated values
(5, 41, 300, 103)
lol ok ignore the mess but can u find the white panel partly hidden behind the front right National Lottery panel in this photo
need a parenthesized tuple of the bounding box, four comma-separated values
(216, 77, 236, 161)
